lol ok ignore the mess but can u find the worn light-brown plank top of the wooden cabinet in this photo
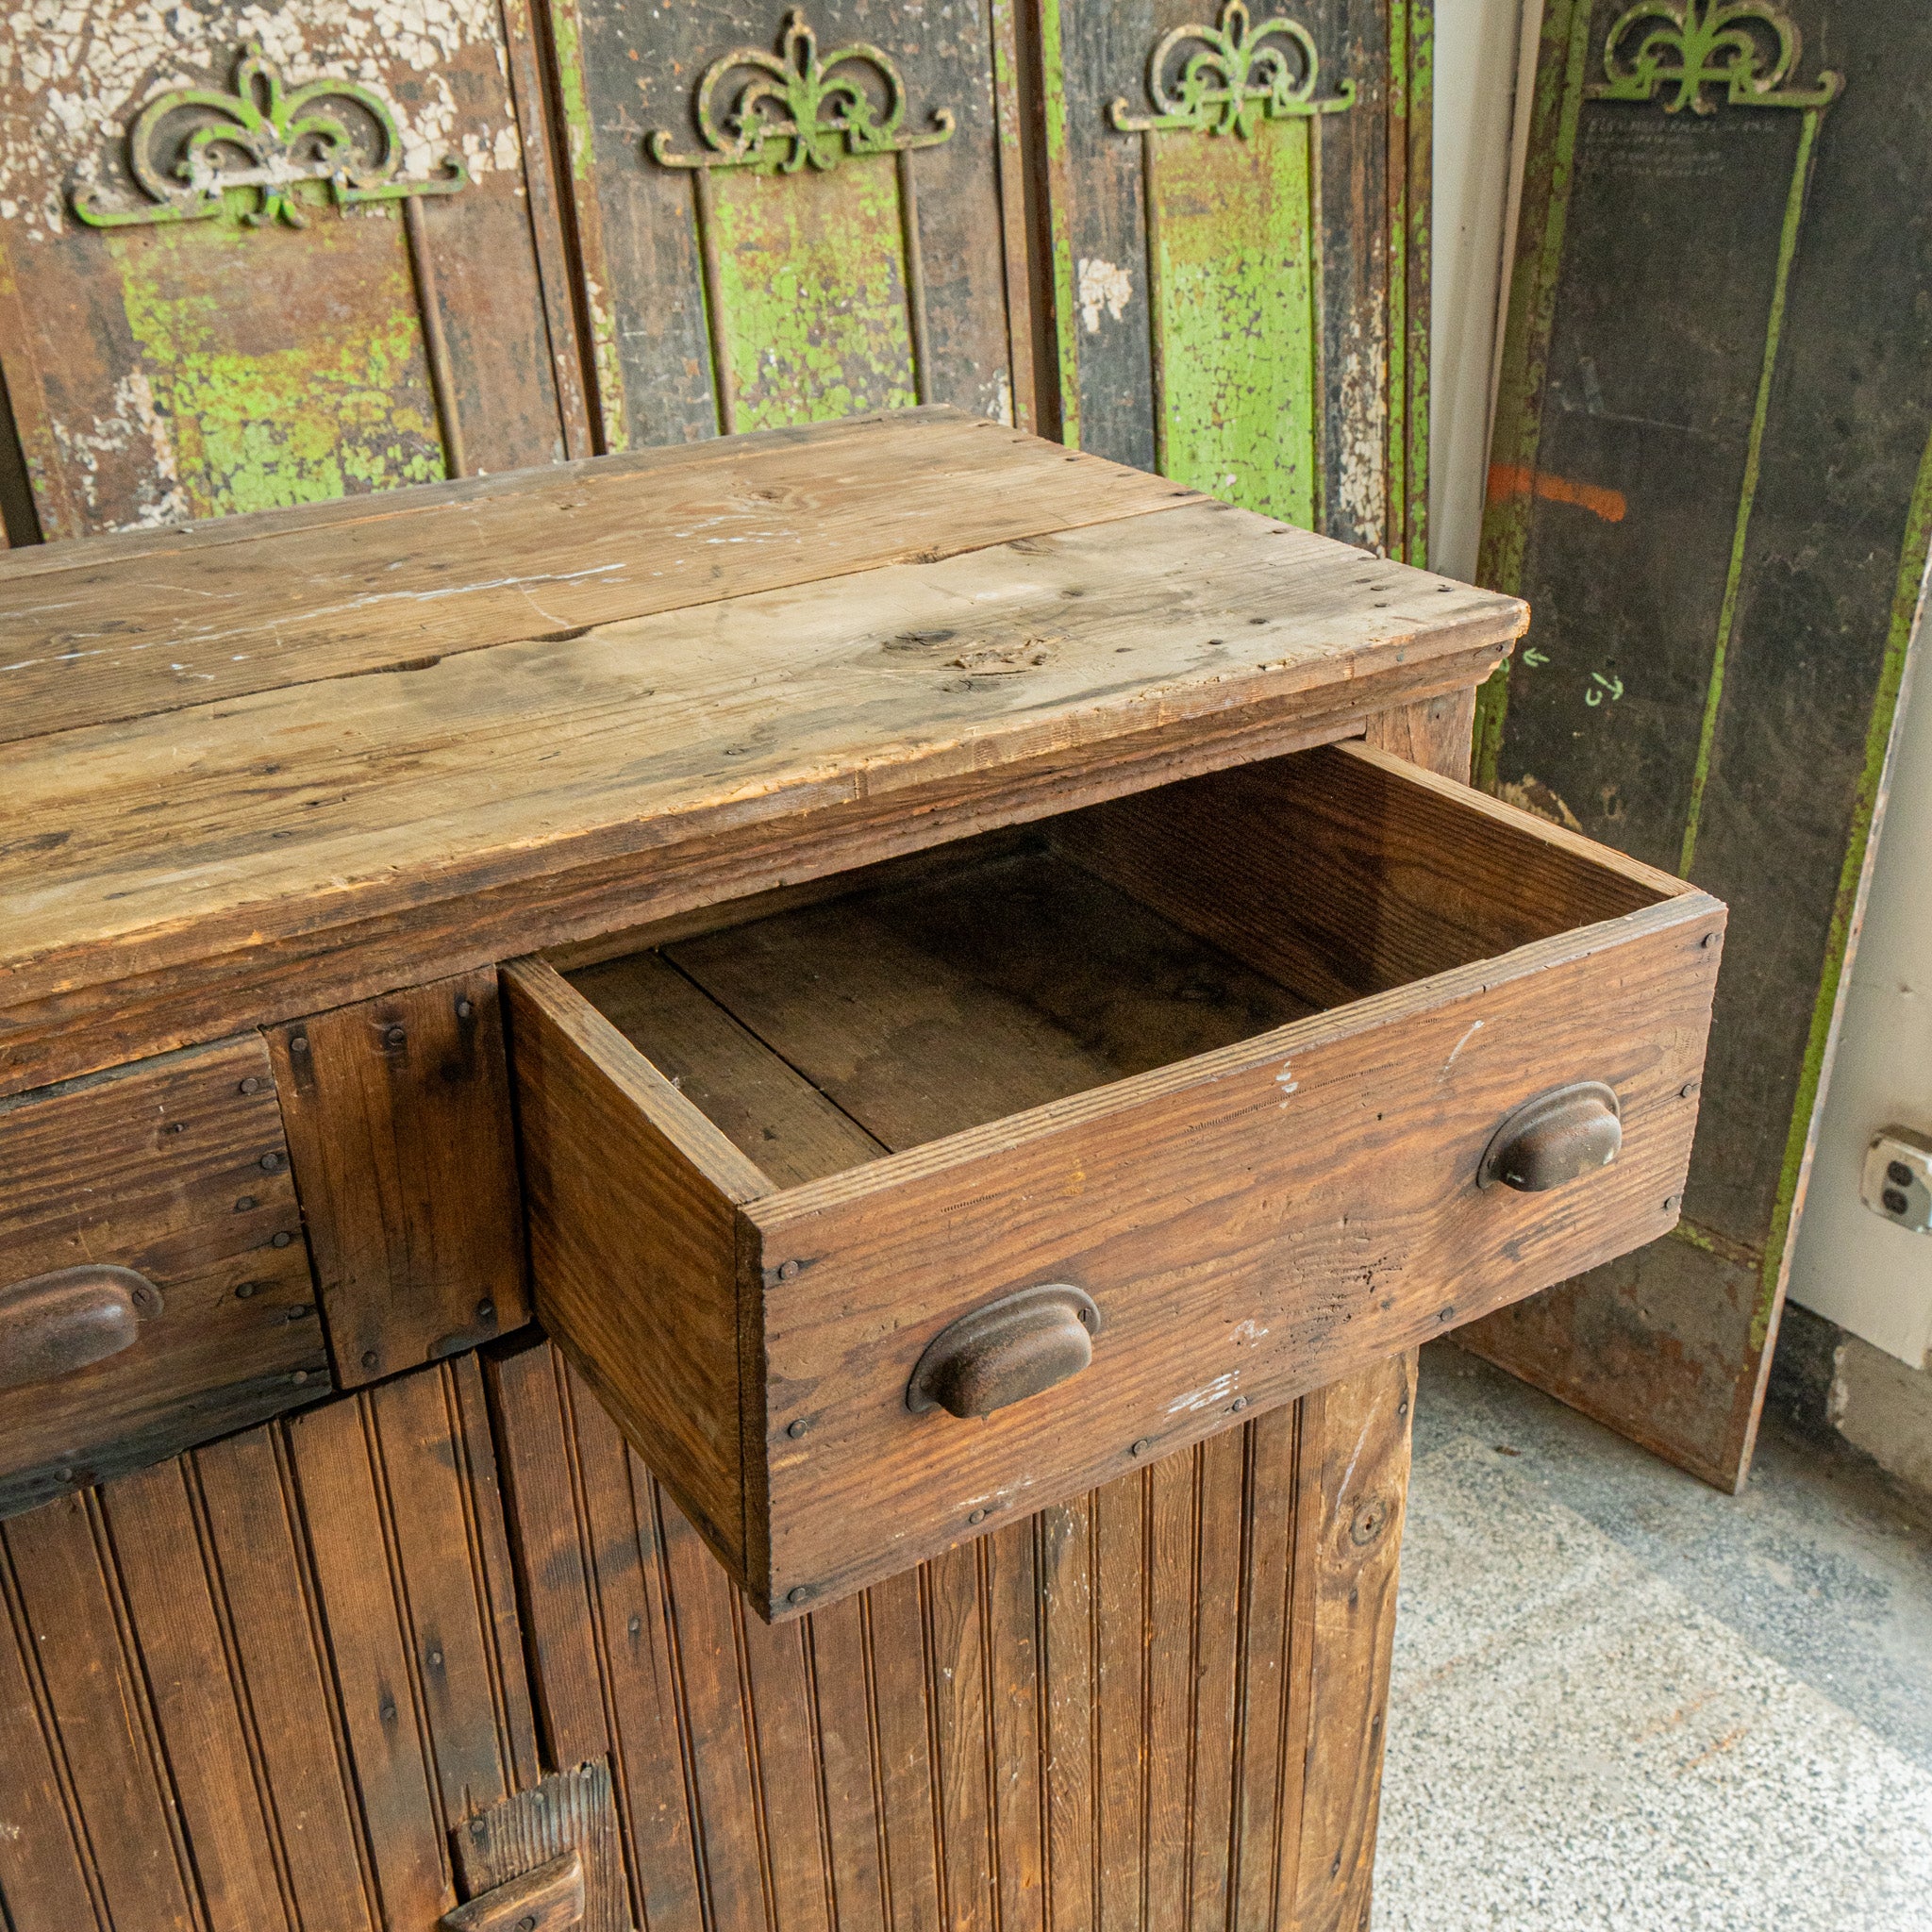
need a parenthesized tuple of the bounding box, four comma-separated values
(0, 409, 1524, 1091)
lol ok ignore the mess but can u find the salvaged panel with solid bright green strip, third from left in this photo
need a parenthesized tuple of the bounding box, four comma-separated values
(1038, 0, 1432, 562)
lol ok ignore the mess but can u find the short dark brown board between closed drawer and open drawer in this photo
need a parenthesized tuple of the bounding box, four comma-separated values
(269, 972, 529, 1390)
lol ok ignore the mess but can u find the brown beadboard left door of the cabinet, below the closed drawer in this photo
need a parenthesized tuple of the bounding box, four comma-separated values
(0, 1357, 539, 1932)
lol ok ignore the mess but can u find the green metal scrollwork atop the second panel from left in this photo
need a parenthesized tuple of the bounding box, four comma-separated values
(649, 8, 953, 174)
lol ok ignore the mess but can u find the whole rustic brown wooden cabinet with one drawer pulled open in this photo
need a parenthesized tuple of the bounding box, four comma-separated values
(0, 409, 1724, 1932)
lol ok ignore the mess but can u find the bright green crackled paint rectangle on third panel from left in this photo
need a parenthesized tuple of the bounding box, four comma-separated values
(1148, 120, 1322, 527)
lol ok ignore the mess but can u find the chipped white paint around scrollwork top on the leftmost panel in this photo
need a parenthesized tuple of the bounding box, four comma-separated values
(0, 0, 522, 240)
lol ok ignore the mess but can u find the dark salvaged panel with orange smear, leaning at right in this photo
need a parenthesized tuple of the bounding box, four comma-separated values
(1471, 0, 1932, 1488)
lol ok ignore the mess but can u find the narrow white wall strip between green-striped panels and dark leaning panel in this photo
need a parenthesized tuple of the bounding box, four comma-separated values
(1430, 0, 1541, 577)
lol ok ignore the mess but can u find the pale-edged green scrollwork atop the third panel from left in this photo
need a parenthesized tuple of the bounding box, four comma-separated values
(1108, 0, 1355, 139)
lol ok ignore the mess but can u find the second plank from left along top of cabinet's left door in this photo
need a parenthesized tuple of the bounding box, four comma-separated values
(103, 1460, 295, 1932)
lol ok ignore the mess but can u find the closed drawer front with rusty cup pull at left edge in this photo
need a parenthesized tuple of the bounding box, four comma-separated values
(0, 1036, 320, 1515)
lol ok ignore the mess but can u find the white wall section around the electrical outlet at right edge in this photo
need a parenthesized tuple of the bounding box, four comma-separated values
(1790, 591, 1932, 1368)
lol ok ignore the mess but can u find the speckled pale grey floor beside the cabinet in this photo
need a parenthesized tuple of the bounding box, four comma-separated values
(1374, 1342, 1932, 1932)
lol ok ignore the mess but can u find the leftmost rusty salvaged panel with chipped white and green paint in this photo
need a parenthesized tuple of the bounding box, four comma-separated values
(0, 0, 588, 541)
